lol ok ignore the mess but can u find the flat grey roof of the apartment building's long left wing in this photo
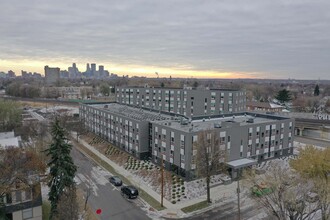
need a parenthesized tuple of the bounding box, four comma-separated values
(88, 103, 171, 121)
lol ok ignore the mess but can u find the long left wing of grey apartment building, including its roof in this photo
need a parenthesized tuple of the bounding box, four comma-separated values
(79, 103, 171, 159)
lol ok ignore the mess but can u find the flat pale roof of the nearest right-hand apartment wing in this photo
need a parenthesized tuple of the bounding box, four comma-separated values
(154, 112, 288, 132)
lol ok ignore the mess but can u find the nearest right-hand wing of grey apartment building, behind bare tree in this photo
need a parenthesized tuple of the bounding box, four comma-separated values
(150, 112, 294, 179)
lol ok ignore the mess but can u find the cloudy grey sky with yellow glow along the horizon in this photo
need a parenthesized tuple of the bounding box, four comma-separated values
(0, 0, 330, 80)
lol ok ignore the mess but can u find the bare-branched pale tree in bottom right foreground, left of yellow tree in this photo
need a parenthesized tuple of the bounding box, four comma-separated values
(243, 161, 319, 220)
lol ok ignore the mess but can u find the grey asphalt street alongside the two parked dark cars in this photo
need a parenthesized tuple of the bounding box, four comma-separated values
(72, 147, 150, 220)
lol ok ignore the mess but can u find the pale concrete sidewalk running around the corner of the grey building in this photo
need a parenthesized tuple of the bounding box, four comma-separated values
(71, 133, 242, 218)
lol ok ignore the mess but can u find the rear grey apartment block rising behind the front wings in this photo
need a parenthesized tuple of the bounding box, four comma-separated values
(116, 87, 246, 117)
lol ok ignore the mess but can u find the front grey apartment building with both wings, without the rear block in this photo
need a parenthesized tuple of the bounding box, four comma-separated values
(80, 103, 294, 180)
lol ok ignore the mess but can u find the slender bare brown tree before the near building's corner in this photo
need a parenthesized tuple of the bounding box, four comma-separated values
(193, 130, 226, 203)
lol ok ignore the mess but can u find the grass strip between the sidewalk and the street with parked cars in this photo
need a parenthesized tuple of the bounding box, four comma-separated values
(79, 144, 165, 211)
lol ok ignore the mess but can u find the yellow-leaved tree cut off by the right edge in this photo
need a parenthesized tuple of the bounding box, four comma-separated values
(290, 146, 330, 220)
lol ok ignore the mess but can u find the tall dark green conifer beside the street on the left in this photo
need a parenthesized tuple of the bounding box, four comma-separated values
(47, 118, 77, 218)
